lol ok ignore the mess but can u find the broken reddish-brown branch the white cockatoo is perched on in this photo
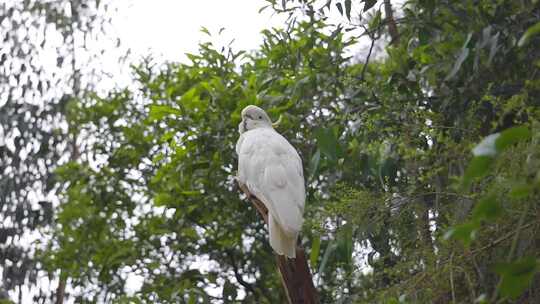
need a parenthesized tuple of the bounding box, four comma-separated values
(238, 181, 319, 304)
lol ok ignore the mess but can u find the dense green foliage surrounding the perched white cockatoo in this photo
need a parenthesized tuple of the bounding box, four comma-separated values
(2, 0, 540, 303)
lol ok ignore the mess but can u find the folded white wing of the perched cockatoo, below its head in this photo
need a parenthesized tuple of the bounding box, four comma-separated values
(236, 128, 305, 239)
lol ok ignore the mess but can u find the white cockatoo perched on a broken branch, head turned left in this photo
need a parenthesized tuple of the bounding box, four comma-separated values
(236, 105, 306, 258)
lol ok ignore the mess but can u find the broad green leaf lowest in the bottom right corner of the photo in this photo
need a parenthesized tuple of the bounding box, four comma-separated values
(495, 257, 538, 299)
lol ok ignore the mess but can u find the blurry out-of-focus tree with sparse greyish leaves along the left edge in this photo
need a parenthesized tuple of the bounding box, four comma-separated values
(0, 0, 123, 302)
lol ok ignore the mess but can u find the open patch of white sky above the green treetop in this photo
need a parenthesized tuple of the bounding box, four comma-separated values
(113, 0, 285, 61)
